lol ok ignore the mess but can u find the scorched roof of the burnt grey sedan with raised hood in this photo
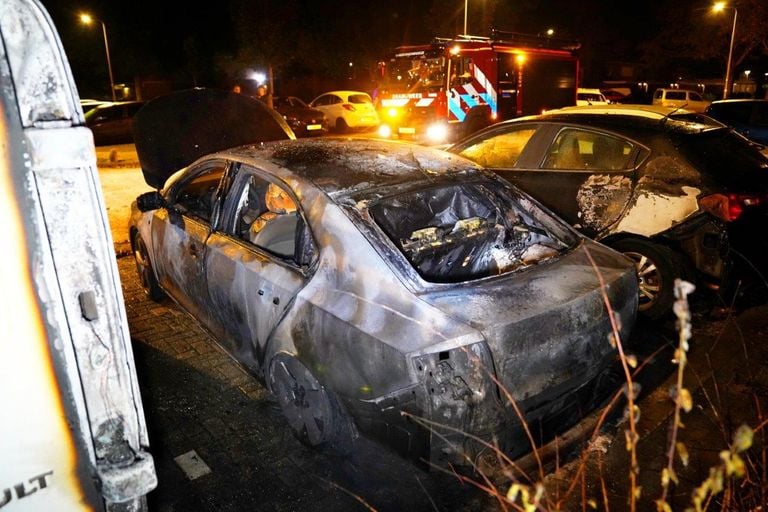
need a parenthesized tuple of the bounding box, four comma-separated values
(213, 137, 490, 195)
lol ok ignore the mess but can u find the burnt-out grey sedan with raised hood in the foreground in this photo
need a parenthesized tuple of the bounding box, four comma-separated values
(130, 89, 637, 463)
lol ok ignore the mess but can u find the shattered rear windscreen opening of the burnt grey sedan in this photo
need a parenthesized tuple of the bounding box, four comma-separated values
(370, 183, 574, 283)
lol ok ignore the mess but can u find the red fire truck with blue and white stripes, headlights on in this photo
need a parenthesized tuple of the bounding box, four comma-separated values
(375, 30, 580, 142)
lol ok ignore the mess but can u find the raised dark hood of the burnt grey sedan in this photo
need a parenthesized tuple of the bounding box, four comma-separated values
(133, 89, 296, 189)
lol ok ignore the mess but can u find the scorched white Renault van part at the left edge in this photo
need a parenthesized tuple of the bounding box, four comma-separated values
(0, 0, 157, 511)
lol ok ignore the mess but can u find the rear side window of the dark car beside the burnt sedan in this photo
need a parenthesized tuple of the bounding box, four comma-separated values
(543, 129, 633, 171)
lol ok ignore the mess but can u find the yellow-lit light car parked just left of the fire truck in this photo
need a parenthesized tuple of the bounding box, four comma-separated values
(309, 91, 380, 132)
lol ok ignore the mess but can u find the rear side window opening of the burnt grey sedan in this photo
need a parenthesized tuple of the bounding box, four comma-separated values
(237, 175, 303, 260)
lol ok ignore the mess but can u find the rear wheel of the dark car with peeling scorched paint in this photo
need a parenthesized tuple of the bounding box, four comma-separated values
(609, 239, 682, 319)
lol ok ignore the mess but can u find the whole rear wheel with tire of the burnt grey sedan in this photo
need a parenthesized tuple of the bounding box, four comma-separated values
(269, 354, 356, 455)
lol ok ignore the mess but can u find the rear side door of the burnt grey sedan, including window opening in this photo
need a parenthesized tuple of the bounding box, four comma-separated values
(205, 165, 314, 370)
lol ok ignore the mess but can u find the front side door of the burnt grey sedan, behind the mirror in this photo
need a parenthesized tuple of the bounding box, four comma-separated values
(152, 160, 227, 325)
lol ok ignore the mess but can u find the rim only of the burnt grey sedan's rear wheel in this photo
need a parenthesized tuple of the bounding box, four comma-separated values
(272, 359, 330, 446)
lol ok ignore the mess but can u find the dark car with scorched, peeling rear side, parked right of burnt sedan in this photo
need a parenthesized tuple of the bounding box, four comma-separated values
(448, 105, 768, 318)
